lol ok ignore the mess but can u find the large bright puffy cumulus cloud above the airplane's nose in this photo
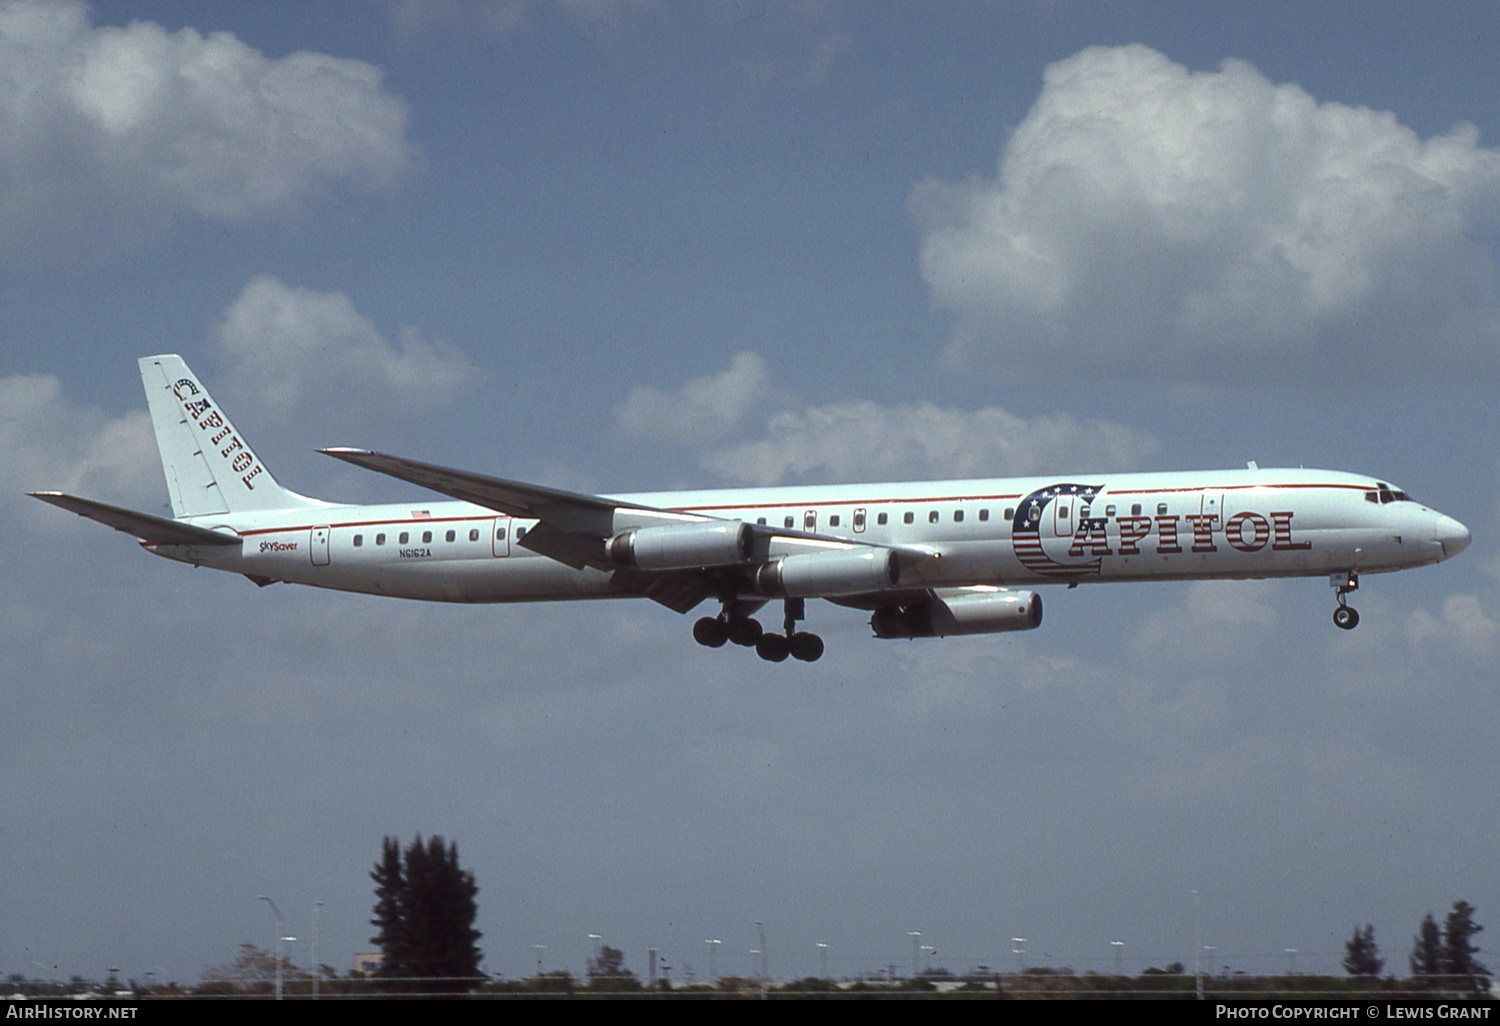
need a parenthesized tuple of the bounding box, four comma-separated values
(912, 45, 1500, 381)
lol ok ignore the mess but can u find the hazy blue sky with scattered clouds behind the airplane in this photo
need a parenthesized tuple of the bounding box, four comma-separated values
(0, 0, 1500, 983)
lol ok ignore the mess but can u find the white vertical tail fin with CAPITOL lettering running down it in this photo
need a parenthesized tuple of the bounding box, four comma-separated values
(140, 356, 321, 518)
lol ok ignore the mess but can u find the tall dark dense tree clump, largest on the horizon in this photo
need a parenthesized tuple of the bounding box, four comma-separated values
(371, 834, 483, 993)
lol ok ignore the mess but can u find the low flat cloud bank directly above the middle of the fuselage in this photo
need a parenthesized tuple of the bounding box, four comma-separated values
(615, 353, 1157, 485)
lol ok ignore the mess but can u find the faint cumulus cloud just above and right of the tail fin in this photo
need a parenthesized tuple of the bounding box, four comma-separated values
(213, 275, 473, 417)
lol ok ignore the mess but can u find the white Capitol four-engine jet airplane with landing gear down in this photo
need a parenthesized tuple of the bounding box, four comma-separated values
(30, 356, 1470, 662)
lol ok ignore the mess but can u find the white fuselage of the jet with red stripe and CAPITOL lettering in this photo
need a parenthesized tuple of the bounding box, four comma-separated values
(147, 470, 1469, 603)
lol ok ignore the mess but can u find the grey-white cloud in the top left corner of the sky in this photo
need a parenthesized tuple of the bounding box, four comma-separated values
(0, 0, 416, 254)
